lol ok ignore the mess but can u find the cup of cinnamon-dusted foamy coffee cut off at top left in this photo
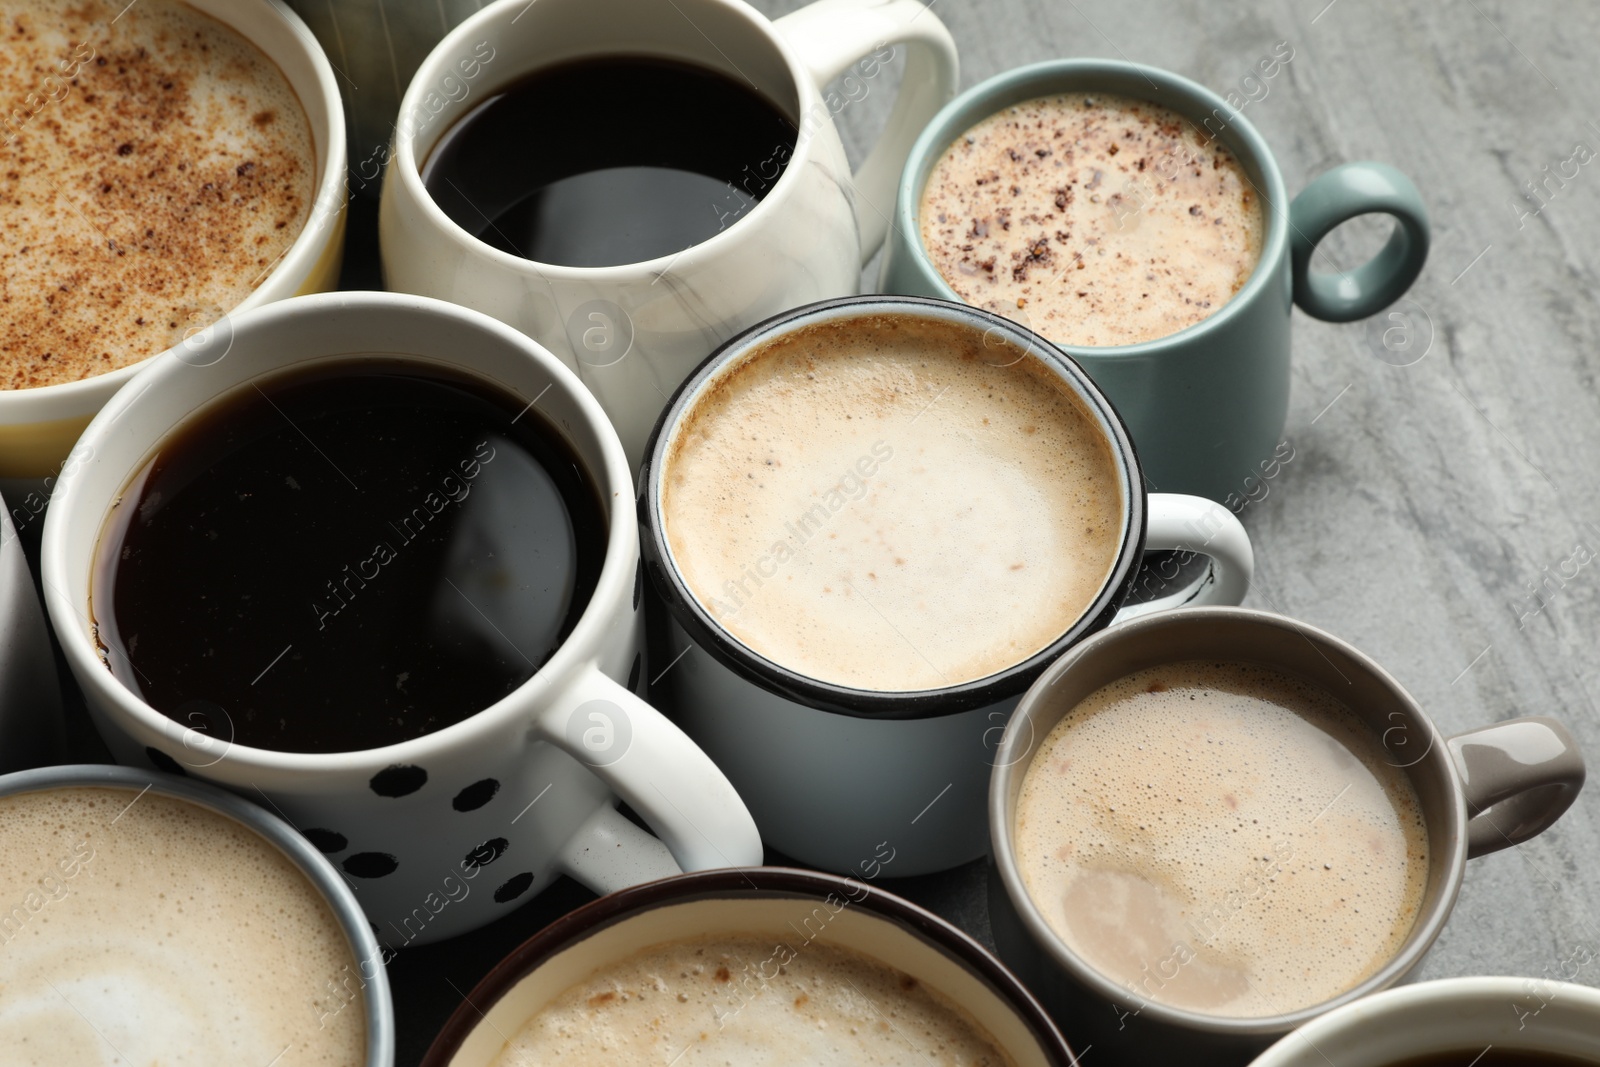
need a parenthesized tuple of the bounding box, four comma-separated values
(0, 0, 346, 502)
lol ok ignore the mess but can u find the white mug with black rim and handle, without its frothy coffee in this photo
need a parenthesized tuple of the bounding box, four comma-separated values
(638, 296, 1254, 875)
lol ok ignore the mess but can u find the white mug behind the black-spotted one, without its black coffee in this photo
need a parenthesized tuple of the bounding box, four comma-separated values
(379, 0, 957, 466)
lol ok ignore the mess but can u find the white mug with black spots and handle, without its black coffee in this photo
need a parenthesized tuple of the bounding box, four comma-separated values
(42, 293, 762, 947)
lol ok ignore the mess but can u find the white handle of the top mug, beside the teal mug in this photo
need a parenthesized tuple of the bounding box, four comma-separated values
(774, 0, 958, 264)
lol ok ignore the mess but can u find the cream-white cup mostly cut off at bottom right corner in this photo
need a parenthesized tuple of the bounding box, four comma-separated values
(1251, 979, 1600, 1067)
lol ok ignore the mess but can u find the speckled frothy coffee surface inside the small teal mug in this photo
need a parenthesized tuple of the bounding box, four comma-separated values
(920, 93, 1262, 346)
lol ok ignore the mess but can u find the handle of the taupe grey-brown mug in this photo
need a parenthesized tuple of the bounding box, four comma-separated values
(1445, 715, 1586, 859)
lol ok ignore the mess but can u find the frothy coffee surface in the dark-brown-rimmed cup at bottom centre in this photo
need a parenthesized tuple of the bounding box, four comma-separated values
(494, 934, 1011, 1067)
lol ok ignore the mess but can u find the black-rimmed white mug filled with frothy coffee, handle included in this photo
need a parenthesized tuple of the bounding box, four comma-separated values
(640, 298, 1253, 875)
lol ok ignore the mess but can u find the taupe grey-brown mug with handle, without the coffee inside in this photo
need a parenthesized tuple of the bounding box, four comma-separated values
(989, 608, 1584, 1065)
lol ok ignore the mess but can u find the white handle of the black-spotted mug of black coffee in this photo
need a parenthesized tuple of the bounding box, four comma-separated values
(536, 664, 762, 893)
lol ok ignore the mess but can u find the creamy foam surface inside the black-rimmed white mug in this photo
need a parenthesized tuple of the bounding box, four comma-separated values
(661, 315, 1123, 691)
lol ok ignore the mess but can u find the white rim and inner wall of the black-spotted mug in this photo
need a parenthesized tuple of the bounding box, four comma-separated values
(42, 293, 638, 769)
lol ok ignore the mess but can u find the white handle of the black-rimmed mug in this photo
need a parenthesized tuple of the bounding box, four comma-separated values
(1112, 493, 1256, 624)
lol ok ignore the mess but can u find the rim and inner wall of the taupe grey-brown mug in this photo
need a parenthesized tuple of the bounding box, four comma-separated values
(989, 608, 1466, 1033)
